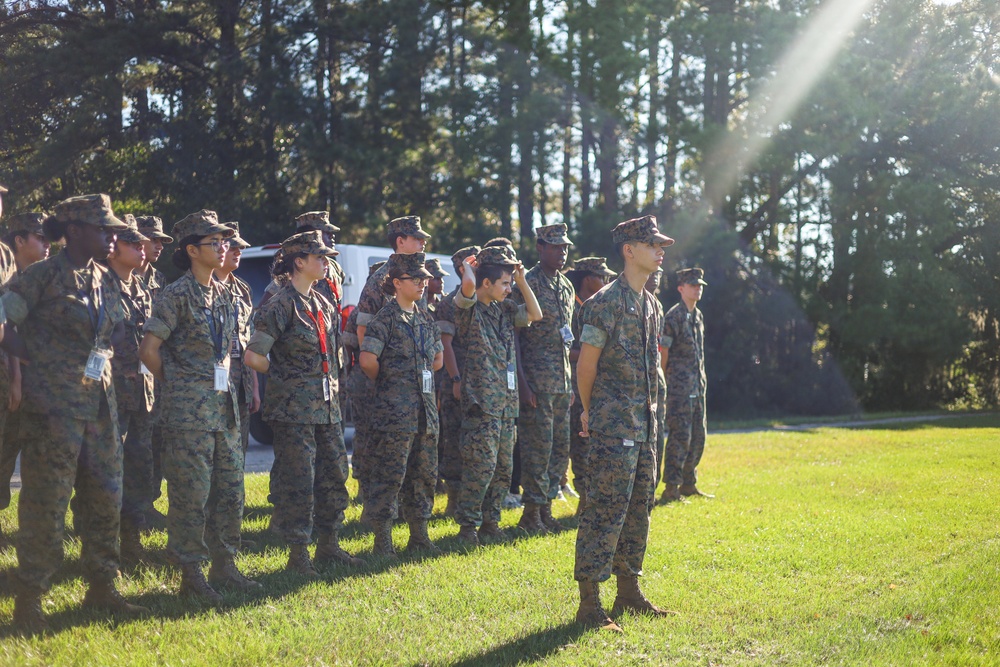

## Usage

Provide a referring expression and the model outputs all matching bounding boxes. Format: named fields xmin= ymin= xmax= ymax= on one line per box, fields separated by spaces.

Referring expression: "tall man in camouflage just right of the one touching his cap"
xmin=511 ymin=224 xmax=576 ymax=533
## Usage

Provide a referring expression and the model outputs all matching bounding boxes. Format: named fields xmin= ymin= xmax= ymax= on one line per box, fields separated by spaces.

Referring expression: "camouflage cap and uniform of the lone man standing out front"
xmin=574 ymin=216 xmax=666 ymax=583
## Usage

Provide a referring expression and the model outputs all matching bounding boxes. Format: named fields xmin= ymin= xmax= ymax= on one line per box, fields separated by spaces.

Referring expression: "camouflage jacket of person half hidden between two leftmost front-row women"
xmin=111 ymin=272 xmax=153 ymax=412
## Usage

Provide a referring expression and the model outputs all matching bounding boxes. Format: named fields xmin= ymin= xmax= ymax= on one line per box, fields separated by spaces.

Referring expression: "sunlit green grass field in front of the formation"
xmin=0 ymin=416 xmax=1000 ymax=666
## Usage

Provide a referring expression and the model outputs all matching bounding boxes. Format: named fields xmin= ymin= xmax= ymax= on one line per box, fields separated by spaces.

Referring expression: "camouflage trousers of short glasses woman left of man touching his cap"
xmin=361 ymin=418 xmax=438 ymax=524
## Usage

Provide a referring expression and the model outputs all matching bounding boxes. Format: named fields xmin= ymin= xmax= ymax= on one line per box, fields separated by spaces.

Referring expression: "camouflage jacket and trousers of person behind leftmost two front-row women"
xmin=111 ymin=250 xmax=154 ymax=528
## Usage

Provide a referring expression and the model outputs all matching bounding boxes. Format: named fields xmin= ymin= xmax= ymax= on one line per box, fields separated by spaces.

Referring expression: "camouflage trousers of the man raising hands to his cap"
xmin=455 ymin=405 xmax=517 ymax=526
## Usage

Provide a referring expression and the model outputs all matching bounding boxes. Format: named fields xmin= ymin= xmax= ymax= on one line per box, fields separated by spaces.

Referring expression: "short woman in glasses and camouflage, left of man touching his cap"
xmin=360 ymin=252 xmax=444 ymax=556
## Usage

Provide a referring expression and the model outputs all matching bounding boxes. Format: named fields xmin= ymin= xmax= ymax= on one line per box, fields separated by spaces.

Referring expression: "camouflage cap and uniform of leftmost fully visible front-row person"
xmin=3 ymin=195 xmax=131 ymax=595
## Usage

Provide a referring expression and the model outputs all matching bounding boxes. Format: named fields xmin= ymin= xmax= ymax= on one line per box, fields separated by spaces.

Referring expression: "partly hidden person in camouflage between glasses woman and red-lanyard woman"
xmin=215 ymin=222 xmax=260 ymax=456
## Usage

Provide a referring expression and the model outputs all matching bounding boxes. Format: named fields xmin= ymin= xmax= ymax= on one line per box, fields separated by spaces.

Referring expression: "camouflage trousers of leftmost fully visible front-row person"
xmin=17 ymin=399 xmax=122 ymax=593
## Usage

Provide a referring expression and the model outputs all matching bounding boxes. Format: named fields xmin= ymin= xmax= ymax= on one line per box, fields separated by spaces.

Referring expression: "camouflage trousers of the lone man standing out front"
xmin=574 ymin=431 xmax=655 ymax=583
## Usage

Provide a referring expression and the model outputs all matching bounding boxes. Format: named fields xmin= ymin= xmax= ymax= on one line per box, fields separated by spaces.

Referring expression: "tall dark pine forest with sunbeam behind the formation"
xmin=0 ymin=0 xmax=1000 ymax=417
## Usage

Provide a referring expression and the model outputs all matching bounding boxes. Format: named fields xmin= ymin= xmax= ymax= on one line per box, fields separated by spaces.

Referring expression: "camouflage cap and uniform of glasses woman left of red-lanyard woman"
xmin=144 ymin=211 xmax=244 ymax=565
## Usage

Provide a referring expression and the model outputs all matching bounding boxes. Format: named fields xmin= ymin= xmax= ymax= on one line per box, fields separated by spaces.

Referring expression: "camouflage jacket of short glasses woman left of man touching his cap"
xmin=361 ymin=300 xmax=444 ymax=433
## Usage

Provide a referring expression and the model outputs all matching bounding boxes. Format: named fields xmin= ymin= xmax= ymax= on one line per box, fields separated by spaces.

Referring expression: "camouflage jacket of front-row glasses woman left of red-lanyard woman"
xmin=143 ymin=271 xmax=239 ymax=432
